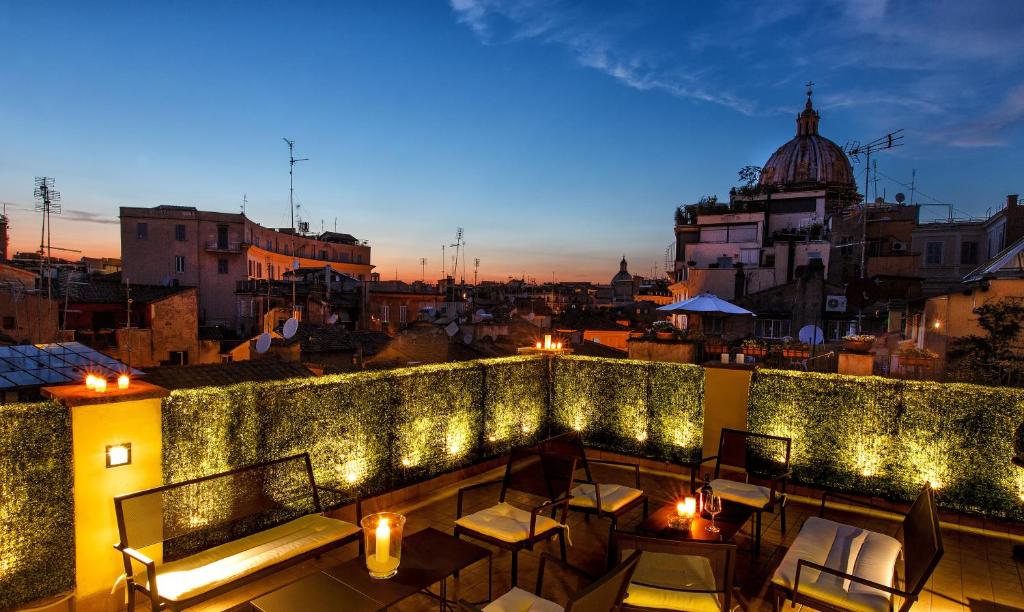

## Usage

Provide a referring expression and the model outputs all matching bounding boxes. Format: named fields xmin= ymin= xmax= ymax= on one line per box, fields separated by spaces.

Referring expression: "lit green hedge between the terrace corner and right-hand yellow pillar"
xmin=551 ymin=357 xmax=703 ymax=461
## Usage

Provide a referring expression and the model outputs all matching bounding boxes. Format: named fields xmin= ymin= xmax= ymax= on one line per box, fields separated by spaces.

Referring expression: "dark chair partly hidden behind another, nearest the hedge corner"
xmin=539 ymin=431 xmax=647 ymax=529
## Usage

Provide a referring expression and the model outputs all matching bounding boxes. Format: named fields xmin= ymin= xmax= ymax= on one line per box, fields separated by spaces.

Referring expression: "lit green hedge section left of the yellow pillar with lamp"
xmin=0 ymin=402 xmax=75 ymax=610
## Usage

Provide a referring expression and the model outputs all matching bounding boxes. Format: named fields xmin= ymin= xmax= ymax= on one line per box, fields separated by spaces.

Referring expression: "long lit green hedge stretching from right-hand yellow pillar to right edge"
xmin=748 ymin=369 xmax=1024 ymax=519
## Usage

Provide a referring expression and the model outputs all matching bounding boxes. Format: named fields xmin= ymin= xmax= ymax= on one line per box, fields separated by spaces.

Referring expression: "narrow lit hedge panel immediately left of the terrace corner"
xmin=477 ymin=355 xmax=550 ymax=457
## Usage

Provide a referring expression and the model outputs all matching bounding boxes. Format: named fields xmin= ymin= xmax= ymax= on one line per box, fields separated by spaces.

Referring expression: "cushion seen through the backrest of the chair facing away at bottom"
xmin=622 ymin=550 xmax=722 ymax=612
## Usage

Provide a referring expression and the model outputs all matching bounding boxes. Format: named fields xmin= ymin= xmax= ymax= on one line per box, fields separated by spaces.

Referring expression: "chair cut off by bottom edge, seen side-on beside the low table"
xmin=459 ymin=553 xmax=640 ymax=612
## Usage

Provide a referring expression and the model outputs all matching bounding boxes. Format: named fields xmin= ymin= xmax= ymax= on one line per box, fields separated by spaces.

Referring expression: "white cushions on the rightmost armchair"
xmin=771 ymin=517 xmax=901 ymax=612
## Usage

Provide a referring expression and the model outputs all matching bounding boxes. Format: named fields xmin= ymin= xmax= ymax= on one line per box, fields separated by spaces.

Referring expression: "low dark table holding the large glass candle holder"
xmin=251 ymin=527 xmax=492 ymax=612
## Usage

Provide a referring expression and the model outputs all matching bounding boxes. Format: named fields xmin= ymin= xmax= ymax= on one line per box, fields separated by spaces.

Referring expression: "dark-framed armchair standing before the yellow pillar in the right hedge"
xmin=700 ymin=428 xmax=793 ymax=555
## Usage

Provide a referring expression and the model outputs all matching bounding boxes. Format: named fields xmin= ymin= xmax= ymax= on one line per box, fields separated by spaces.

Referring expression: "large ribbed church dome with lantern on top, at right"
xmin=758 ymin=91 xmax=856 ymax=189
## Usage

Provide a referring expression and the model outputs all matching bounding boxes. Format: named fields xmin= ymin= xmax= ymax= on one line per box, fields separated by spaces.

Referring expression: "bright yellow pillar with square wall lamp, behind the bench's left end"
xmin=72 ymin=398 xmax=162 ymax=612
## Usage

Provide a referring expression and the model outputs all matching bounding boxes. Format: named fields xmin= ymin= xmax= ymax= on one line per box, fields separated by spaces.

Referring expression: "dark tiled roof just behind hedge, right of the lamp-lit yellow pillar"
xmin=145 ymin=359 xmax=312 ymax=390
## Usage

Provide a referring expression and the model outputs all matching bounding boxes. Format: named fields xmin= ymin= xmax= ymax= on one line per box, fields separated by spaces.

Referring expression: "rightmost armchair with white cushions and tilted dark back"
xmin=771 ymin=484 xmax=942 ymax=612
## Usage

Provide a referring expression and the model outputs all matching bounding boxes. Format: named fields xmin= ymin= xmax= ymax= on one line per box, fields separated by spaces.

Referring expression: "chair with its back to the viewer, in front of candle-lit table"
xmin=608 ymin=530 xmax=736 ymax=611
